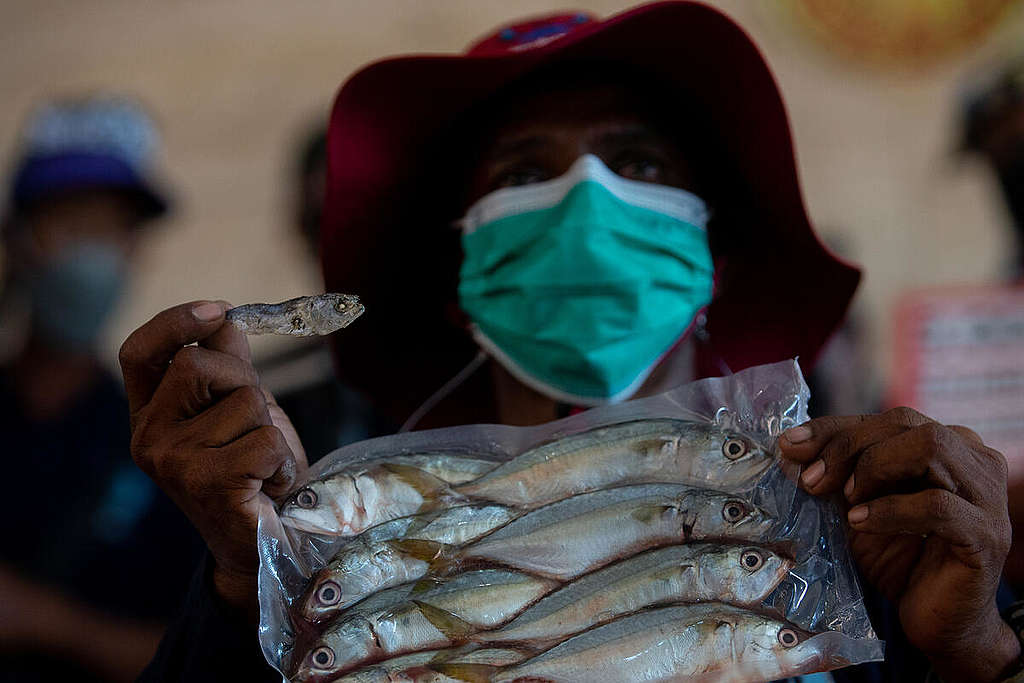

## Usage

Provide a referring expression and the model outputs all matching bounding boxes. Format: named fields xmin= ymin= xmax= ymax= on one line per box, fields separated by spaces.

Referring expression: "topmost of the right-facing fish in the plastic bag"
xmin=456 ymin=420 xmax=772 ymax=507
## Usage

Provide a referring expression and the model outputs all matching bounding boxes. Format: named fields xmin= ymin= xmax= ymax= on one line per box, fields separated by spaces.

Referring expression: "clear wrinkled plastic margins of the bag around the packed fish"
xmin=258 ymin=360 xmax=883 ymax=680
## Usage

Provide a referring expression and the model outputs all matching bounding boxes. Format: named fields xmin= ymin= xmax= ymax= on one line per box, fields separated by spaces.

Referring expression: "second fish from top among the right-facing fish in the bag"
xmin=432 ymin=484 xmax=773 ymax=581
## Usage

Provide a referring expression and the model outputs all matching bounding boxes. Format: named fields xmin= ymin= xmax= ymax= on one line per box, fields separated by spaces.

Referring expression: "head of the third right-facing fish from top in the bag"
xmin=697 ymin=546 xmax=794 ymax=604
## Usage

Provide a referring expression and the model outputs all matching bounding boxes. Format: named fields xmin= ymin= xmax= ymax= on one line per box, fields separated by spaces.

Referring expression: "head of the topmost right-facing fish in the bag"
xmin=676 ymin=424 xmax=774 ymax=489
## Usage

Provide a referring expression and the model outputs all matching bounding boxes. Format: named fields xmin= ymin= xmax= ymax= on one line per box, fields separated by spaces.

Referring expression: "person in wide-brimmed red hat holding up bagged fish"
xmin=121 ymin=2 xmax=1020 ymax=681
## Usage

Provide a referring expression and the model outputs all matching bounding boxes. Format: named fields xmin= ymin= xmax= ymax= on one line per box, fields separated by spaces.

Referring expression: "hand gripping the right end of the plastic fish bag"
xmin=779 ymin=408 xmax=1020 ymax=683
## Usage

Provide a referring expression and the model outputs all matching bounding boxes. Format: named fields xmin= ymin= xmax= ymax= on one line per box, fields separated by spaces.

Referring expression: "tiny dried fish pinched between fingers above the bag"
xmin=225 ymin=294 xmax=365 ymax=337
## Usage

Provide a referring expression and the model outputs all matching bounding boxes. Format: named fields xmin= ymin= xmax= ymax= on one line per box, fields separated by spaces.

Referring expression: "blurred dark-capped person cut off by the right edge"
xmin=962 ymin=54 xmax=1024 ymax=280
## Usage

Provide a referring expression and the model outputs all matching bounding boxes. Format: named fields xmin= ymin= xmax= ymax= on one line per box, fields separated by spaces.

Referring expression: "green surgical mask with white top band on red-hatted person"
xmin=459 ymin=155 xmax=714 ymax=405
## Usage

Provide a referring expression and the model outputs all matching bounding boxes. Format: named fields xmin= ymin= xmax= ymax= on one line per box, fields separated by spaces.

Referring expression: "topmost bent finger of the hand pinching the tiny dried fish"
xmin=118 ymin=301 xmax=224 ymax=413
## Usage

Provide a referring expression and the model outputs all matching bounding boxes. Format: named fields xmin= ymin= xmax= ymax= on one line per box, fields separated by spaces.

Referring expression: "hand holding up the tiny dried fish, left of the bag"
xmin=120 ymin=301 xmax=306 ymax=620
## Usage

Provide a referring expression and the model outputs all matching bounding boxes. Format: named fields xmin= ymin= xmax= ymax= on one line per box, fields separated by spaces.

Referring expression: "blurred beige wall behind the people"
xmin=0 ymin=0 xmax=1024 ymax=389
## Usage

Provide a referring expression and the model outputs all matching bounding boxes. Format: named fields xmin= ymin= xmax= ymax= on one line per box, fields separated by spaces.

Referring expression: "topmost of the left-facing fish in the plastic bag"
xmin=281 ymin=453 xmax=496 ymax=536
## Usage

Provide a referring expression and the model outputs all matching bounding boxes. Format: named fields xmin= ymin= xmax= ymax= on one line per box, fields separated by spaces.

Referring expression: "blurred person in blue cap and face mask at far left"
xmin=0 ymin=96 xmax=201 ymax=682
